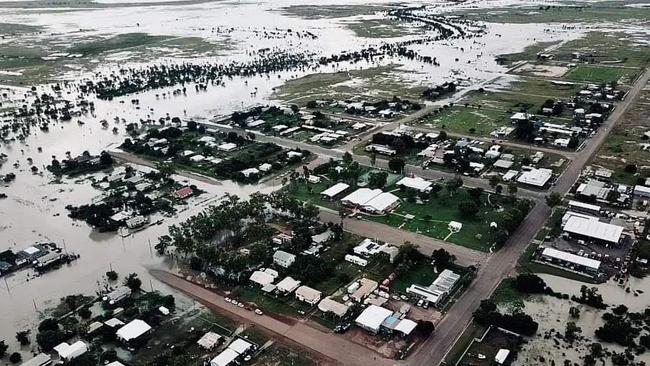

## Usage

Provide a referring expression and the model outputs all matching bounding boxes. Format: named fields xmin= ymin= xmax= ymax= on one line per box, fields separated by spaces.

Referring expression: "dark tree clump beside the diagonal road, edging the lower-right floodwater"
xmin=474 ymin=300 xmax=539 ymax=336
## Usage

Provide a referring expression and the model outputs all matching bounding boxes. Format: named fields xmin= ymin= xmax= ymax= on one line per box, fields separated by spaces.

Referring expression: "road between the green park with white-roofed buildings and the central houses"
xmin=319 ymin=209 xmax=488 ymax=266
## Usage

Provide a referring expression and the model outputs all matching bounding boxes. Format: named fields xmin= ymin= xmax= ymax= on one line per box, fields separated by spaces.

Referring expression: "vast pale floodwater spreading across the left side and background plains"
xmin=0 ymin=0 xmax=636 ymax=349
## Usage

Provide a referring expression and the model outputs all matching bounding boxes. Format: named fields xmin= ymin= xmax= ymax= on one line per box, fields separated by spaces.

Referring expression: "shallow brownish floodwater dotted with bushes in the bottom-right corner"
xmin=513 ymin=274 xmax=650 ymax=366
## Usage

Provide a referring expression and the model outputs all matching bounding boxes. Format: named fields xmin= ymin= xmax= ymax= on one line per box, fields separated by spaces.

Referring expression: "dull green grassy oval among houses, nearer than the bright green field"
xmin=424 ymin=106 xmax=510 ymax=137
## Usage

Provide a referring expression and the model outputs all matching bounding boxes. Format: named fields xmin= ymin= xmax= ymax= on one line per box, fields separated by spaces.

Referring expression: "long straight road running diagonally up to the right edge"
xmin=408 ymin=70 xmax=650 ymax=366
